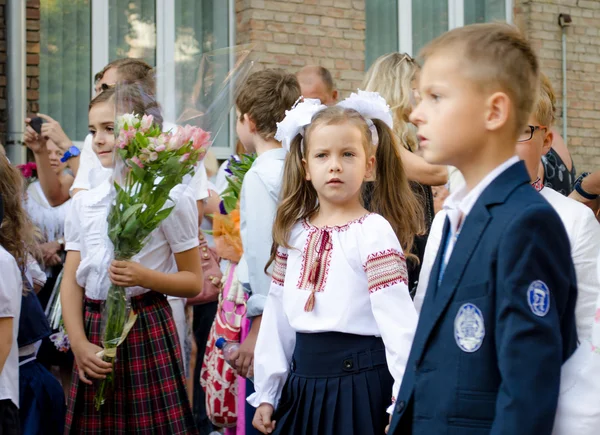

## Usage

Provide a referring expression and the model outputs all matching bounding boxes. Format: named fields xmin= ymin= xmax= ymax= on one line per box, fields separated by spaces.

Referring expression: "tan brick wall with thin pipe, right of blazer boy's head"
xmin=514 ymin=0 xmax=600 ymax=173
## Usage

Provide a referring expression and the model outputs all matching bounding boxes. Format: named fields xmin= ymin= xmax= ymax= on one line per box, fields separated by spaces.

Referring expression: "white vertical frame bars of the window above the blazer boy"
xmin=398 ymin=0 xmax=514 ymax=56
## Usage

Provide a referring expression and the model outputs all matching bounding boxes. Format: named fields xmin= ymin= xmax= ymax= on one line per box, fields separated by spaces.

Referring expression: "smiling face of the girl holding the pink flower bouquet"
xmin=89 ymin=101 xmax=115 ymax=168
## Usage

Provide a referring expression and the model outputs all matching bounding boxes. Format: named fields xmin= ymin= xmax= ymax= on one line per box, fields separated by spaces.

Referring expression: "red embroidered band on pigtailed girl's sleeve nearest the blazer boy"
xmin=363 ymin=249 xmax=408 ymax=293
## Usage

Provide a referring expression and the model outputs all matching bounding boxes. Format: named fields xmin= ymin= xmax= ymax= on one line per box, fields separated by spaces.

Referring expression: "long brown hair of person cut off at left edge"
xmin=0 ymin=155 xmax=38 ymax=272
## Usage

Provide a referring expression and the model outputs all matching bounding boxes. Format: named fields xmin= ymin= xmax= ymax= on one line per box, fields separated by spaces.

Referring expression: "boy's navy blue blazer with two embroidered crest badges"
xmin=388 ymin=162 xmax=577 ymax=435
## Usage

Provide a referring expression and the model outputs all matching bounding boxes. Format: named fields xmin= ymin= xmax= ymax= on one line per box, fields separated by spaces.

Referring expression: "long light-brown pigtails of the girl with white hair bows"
xmin=265 ymin=106 xmax=424 ymax=270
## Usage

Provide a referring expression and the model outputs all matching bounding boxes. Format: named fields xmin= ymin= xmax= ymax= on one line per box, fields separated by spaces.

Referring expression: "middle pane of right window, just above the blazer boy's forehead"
xmin=412 ymin=0 xmax=448 ymax=56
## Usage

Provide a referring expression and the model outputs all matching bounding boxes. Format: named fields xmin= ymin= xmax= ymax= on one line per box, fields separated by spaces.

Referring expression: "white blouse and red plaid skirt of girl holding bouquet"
xmin=65 ymin=180 xmax=198 ymax=434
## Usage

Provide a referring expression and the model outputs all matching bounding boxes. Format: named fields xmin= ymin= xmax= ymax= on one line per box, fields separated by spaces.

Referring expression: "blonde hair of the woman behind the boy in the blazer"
xmin=362 ymin=53 xmax=419 ymax=151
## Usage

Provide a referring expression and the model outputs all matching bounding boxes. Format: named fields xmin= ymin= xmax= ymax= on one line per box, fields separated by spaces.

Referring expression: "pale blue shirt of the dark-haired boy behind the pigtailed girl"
xmin=237 ymin=148 xmax=287 ymax=317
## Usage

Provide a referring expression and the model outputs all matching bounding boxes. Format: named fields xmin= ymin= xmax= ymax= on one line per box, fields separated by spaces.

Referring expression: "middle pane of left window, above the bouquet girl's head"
xmin=108 ymin=0 xmax=156 ymax=66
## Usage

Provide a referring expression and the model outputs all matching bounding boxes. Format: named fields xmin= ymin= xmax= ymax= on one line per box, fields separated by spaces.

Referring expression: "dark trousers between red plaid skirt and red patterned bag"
xmin=193 ymin=302 xmax=218 ymax=435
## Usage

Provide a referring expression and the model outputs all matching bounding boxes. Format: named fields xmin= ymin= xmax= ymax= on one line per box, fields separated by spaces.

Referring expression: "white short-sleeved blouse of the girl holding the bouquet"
xmin=65 ymin=180 xmax=198 ymax=300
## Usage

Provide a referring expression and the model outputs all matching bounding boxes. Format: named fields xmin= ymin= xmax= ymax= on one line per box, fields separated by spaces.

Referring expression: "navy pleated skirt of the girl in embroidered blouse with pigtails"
xmin=273 ymin=332 xmax=394 ymax=435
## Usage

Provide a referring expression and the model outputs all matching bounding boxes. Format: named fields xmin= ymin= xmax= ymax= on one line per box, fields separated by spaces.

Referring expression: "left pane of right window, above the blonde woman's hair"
xmin=365 ymin=0 xmax=398 ymax=69
